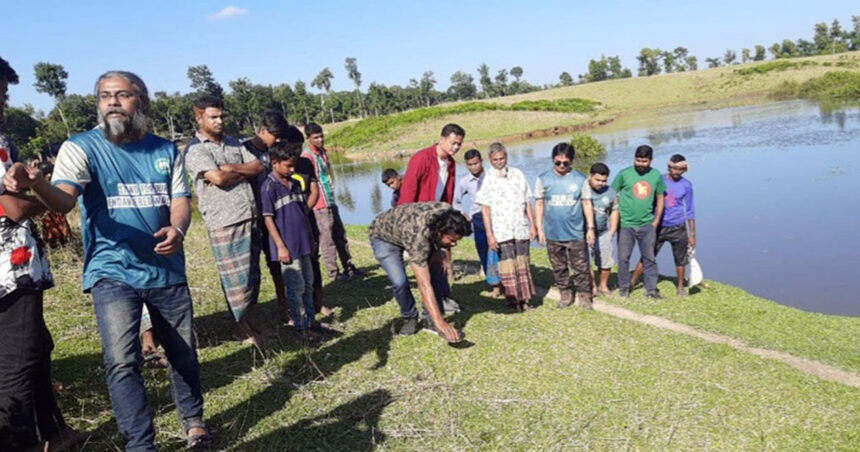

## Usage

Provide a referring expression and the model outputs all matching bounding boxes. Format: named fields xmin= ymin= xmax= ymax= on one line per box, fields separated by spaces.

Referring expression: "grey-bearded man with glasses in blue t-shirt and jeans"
xmin=5 ymin=71 xmax=212 ymax=451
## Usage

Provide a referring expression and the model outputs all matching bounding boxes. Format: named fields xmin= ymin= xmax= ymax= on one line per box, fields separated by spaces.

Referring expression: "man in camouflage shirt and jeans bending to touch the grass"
xmin=367 ymin=202 xmax=472 ymax=342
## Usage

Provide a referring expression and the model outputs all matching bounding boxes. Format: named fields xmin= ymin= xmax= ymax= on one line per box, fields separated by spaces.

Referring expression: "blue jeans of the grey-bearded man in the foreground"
xmin=92 ymin=279 xmax=203 ymax=452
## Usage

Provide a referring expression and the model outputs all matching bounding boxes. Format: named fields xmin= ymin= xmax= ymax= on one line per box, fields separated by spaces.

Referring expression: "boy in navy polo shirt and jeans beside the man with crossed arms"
xmin=260 ymin=142 xmax=320 ymax=341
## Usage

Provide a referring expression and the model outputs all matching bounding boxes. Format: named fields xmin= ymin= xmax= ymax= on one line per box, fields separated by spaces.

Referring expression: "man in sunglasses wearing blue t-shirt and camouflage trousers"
xmin=535 ymin=143 xmax=594 ymax=309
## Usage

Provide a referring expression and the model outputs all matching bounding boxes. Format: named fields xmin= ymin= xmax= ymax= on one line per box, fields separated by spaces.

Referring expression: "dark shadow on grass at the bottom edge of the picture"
xmin=235 ymin=389 xmax=394 ymax=451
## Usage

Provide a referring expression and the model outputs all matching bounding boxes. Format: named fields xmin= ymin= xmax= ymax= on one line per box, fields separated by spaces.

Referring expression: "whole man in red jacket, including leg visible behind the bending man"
xmin=397 ymin=124 xmax=466 ymax=314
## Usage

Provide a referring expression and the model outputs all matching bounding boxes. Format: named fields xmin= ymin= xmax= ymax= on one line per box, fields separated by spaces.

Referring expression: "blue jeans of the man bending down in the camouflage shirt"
xmin=370 ymin=239 xmax=451 ymax=319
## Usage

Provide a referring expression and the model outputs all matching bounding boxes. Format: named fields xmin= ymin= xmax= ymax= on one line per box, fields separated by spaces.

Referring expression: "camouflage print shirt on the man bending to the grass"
xmin=367 ymin=202 xmax=451 ymax=267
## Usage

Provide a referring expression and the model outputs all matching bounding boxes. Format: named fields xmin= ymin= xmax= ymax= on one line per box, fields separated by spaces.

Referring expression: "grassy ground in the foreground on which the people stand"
xmin=46 ymin=220 xmax=860 ymax=451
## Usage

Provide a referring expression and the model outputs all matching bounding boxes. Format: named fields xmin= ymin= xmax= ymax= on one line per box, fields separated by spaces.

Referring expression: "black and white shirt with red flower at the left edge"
xmin=0 ymin=133 xmax=54 ymax=298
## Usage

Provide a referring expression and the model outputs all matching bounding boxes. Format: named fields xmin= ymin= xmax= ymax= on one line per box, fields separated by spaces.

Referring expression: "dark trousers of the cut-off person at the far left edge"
xmin=0 ymin=290 xmax=66 ymax=451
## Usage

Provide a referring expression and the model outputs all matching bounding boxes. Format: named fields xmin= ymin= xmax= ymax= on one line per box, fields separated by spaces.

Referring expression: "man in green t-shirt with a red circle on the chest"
xmin=612 ymin=145 xmax=666 ymax=299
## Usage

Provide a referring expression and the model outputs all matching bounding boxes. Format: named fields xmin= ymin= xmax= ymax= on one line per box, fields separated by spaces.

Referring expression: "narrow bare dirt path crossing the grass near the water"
xmin=350 ymin=240 xmax=860 ymax=388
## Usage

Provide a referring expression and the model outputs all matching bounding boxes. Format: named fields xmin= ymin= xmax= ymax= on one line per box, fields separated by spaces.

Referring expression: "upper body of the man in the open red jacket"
xmin=398 ymin=124 xmax=466 ymax=206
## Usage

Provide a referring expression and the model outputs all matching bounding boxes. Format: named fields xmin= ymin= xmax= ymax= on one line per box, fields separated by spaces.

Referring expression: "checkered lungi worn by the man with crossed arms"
xmin=209 ymin=220 xmax=260 ymax=322
